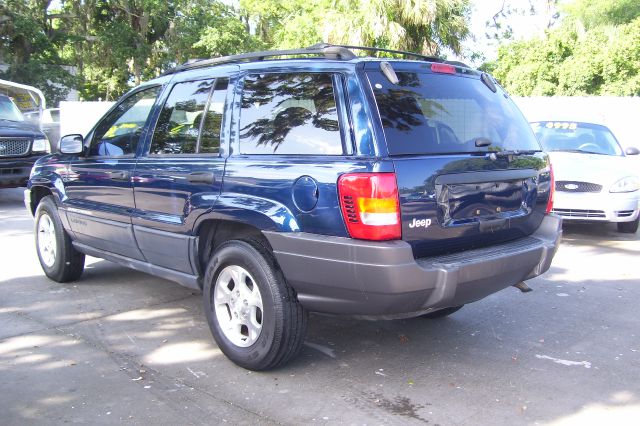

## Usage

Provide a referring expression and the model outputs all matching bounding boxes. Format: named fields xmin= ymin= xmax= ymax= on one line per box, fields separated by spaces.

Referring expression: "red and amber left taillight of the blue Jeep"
xmin=338 ymin=173 xmax=402 ymax=241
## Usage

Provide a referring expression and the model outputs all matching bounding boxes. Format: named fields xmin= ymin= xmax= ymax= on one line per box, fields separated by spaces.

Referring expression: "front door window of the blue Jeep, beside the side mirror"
xmin=89 ymin=86 xmax=160 ymax=157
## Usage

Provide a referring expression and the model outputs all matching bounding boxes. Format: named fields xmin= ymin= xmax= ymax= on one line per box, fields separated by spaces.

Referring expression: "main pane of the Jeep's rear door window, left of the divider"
xmin=149 ymin=80 xmax=213 ymax=154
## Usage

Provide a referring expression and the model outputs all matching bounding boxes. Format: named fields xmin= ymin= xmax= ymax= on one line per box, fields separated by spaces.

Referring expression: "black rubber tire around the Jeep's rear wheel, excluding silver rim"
xmin=203 ymin=240 xmax=307 ymax=371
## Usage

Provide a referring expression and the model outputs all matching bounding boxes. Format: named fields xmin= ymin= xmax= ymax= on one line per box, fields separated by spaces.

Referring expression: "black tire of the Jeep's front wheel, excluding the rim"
xmin=35 ymin=195 xmax=84 ymax=283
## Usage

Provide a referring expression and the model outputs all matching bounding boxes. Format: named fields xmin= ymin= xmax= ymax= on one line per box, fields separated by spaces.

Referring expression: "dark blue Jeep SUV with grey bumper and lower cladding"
xmin=25 ymin=45 xmax=561 ymax=370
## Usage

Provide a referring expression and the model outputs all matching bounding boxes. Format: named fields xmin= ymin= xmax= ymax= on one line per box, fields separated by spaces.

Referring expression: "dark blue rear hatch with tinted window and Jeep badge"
xmin=365 ymin=61 xmax=551 ymax=257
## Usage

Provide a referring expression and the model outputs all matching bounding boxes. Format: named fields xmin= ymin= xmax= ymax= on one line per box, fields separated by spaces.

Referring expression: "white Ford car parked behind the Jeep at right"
xmin=531 ymin=121 xmax=640 ymax=233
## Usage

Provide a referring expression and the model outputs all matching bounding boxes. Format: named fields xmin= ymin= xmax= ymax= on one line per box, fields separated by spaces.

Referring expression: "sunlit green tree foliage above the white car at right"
xmin=488 ymin=0 xmax=640 ymax=96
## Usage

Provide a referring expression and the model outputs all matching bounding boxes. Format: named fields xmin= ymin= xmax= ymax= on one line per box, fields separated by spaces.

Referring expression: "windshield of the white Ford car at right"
xmin=531 ymin=121 xmax=622 ymax=155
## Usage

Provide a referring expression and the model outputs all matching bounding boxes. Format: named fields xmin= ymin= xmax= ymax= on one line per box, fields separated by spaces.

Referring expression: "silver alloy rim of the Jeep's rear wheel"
xmin=213 ymin=265 xmax=263 ymax=348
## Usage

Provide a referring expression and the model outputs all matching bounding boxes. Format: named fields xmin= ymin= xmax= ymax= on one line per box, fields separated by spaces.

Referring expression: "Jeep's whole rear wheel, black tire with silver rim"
xmin=203 ymin=240 xmax=307 ymax=371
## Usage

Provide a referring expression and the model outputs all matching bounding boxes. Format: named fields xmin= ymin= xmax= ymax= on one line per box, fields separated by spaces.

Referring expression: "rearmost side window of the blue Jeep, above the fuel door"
xmin=240 ymin=73 xmax=343 ymax=155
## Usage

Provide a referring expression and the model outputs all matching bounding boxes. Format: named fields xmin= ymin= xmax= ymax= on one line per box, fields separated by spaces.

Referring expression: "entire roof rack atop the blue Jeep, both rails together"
xmin=162 ymin=43 xmax=443 ymax=75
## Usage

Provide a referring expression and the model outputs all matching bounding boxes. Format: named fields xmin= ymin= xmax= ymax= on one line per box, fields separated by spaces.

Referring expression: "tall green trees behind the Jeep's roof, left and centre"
xmin=0 ymin=0 xmax=470 ymax=104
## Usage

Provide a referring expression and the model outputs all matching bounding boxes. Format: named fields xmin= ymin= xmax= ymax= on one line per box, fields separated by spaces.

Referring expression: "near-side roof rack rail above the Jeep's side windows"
xmin=162 ymin=43 xmax=356 ymax=75
